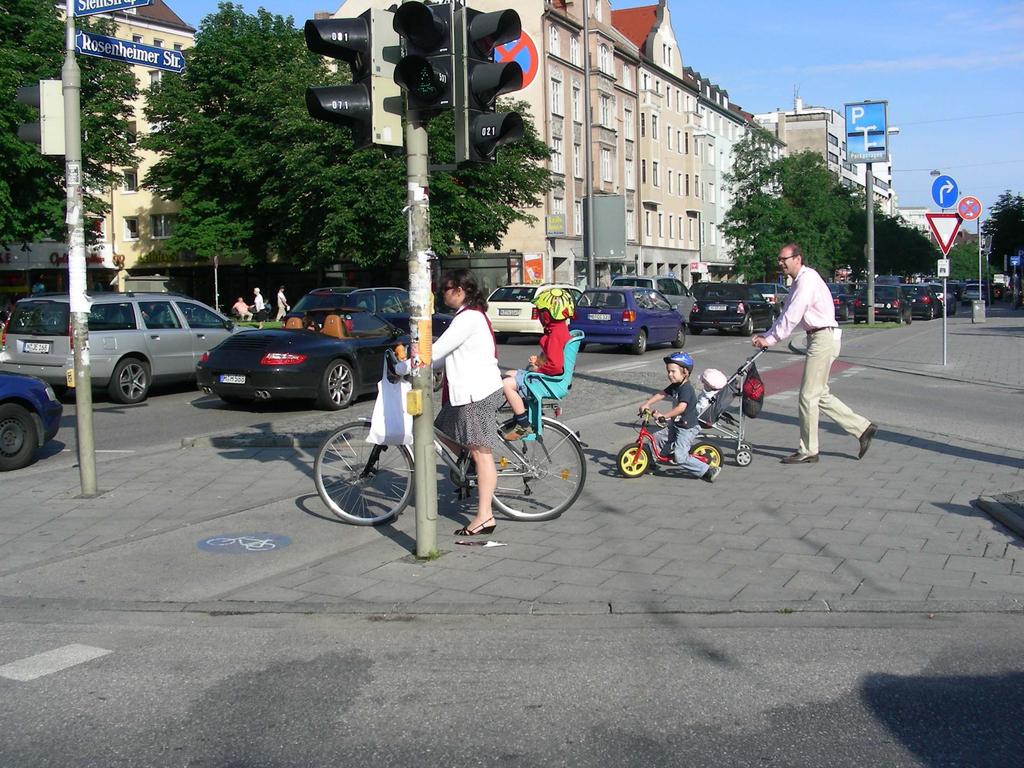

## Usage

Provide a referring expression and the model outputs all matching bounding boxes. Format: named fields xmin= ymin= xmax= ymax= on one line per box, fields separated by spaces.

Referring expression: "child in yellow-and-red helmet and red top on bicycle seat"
xmin=502 ymin=288 xmax=574 ymax=440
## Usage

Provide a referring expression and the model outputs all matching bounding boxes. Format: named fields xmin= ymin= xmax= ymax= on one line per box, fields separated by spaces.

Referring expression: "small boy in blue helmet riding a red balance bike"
xmin=640 ymin=352 xmax=720 ymax=482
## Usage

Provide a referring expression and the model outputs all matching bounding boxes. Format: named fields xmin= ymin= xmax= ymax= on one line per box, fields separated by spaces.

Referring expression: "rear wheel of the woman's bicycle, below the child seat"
xmin=495 ymin=417 xmax=587 ymax=520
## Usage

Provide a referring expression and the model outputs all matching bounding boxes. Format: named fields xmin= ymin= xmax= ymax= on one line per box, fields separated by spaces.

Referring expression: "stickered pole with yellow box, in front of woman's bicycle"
xmin=406 ymin=115 xmax=437 ymax=558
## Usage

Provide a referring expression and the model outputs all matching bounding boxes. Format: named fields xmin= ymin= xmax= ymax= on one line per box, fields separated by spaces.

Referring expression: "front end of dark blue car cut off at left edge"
xmin=0 ymin=374 xmax=63 ymax=472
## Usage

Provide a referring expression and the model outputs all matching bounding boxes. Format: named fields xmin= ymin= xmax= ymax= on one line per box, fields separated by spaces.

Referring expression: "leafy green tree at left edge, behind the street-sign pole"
xmin=0 ymin=0 xmax=137 ymax=243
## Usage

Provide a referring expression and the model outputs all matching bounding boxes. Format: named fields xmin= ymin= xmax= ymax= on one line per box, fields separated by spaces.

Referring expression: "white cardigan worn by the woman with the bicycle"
xmin=431 ymin=307 xmax=502 ymax=406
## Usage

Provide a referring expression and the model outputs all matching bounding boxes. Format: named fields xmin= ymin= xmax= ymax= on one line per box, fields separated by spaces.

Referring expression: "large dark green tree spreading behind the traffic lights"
xmin=143 ymin=3 xmax=551 ymax=266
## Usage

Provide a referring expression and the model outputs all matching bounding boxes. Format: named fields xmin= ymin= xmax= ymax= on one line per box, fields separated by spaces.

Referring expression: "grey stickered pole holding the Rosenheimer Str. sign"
xmin=60 ymin=10 xmax=96 ymax=496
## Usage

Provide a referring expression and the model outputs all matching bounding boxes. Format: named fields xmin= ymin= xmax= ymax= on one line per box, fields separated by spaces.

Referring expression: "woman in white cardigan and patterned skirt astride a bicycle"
xmin=432 ymin=269 xmax=505 ymax=536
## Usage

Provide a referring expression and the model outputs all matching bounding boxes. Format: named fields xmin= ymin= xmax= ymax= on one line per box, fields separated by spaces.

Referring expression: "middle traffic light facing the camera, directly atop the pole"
xmin=394 ymin=2 xmax=455 ymax=113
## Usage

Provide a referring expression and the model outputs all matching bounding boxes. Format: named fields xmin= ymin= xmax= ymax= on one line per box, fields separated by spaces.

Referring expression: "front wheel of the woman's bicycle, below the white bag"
xmin=313 ymin=420 xmax=413 ymax=525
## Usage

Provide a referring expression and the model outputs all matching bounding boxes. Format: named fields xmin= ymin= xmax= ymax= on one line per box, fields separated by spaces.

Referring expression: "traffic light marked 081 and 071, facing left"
xmin=303 ymin=8 xmax=402 ymax=150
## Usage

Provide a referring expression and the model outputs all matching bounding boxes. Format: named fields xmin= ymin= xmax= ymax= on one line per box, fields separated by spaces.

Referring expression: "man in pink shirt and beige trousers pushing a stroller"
xmin=753 ymin=243 xmax=878 ymax=464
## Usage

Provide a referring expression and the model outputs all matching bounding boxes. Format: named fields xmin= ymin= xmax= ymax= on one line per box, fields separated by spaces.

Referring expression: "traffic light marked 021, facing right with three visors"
xmin=455 ymin=8 xmax=523 ymax=163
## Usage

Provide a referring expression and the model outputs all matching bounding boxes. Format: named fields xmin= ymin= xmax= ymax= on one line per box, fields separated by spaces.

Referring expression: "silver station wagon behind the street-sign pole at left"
xmin=0 ymin=293 xmax=237 ymax=403
